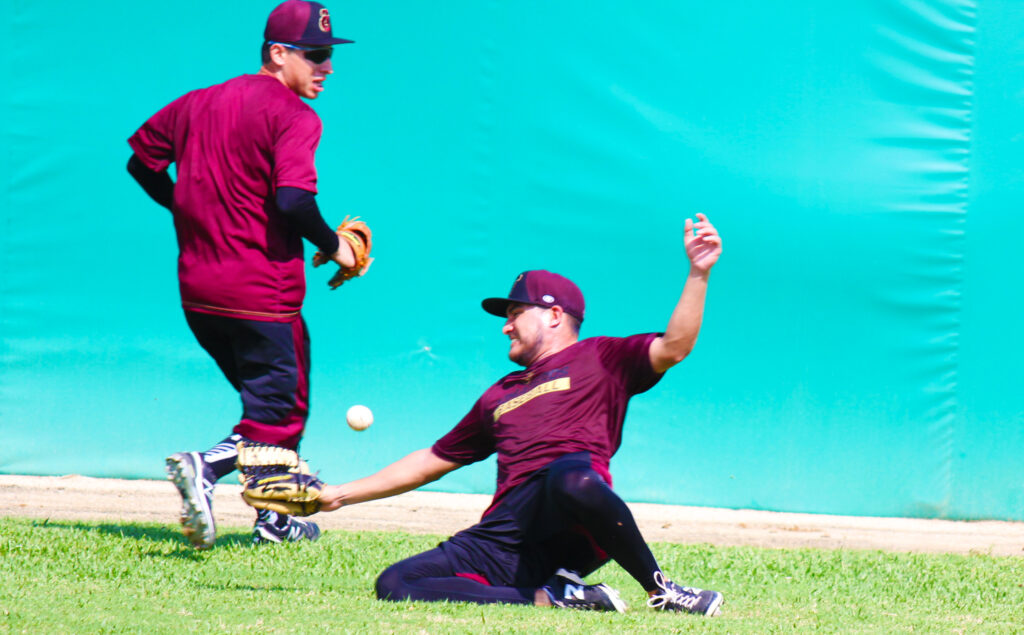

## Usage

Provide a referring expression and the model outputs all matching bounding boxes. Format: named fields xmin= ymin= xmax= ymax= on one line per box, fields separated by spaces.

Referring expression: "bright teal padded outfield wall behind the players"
xmin=0 ymin=0 xmax=1024 ymax=519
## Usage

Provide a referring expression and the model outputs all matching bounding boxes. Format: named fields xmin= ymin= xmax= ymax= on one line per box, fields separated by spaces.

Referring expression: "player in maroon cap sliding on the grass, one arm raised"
xmin=264 ymin=214 xmax=723 ymax=616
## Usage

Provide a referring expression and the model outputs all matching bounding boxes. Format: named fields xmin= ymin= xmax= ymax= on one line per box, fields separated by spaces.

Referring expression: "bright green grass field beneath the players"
xmin=0 ymin=517 xmax=1024 ymax=634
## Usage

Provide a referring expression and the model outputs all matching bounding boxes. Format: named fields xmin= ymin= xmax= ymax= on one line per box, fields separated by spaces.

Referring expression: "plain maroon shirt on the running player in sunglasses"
xmin=128 ymin=75 xmax=322 ymax=322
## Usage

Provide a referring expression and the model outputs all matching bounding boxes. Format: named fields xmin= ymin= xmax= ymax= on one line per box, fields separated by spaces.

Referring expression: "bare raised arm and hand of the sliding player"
xmin=648 ymin=214 xmax=722 ymax=373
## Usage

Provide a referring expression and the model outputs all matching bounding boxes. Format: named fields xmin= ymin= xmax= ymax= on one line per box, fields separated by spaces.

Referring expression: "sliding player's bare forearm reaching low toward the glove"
xmin=319 ymin=448 xmax=462 ymax=511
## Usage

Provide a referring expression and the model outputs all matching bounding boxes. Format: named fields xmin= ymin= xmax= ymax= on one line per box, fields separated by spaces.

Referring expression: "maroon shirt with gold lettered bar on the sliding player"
xmin=432 ymin=333 xmax=662 ymax=509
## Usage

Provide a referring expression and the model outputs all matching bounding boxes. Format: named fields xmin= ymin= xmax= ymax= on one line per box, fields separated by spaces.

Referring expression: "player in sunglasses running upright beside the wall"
xmin=128 ymin=0 xmax=371 ymax=549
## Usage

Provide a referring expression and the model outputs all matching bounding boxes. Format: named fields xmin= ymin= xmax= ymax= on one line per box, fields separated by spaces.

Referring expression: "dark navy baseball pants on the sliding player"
xmin=377 ymin=453 xmax=657 ymax=604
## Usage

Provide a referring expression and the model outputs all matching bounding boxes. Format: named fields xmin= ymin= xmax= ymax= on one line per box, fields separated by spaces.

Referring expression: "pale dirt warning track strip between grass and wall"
xmin=0 ymin=474 xmax=1024 ymax=556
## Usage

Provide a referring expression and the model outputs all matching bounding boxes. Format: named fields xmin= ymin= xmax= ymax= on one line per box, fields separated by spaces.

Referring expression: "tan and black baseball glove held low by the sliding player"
xmin=236 ymin=440 xmax=324 ymax=516
